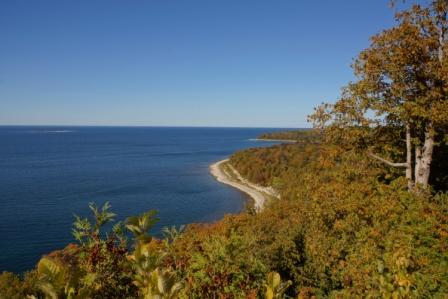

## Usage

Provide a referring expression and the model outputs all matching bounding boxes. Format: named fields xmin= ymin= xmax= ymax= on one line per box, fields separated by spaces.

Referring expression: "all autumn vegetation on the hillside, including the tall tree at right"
xmin=0 ymin=0 xmax=448 ymax=299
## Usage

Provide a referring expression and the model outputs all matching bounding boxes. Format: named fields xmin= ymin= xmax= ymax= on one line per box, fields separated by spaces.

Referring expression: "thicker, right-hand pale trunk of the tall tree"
xmin=415 ymin=123 xmax=434 ymax=188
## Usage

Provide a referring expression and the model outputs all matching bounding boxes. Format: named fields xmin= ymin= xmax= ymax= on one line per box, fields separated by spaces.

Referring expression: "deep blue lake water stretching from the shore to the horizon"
xmin=0 ymin=126 xmax=286 ymax=272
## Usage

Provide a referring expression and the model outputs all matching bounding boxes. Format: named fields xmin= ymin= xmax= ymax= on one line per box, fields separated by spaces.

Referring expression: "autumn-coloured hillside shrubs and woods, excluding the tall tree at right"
xmin=0 ymin=132 xmax=448 ymax=298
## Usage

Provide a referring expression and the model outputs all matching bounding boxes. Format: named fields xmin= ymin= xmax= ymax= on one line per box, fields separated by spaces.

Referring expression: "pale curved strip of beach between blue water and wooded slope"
xmin=209 ymin=159 xmax=280 ymax=212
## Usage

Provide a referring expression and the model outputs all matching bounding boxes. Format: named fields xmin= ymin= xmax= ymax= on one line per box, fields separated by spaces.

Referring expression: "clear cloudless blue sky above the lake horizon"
xmin=0 ymin=0 xmax=412 ymax=127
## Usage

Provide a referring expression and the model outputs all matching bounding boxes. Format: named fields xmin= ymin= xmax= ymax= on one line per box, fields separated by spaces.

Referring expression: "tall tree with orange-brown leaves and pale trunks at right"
xmin=310 ymin=0 xmax=448 ymax=188
